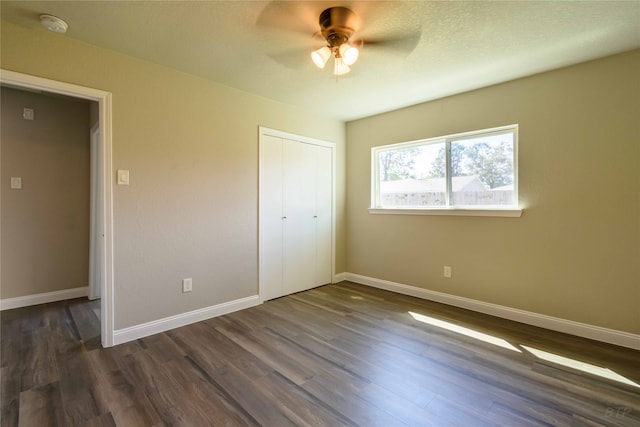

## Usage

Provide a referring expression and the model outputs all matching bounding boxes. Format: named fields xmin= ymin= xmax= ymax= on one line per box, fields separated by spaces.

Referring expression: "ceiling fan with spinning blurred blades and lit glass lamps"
xmin=256 ymin=1 xmax=422 ymax=76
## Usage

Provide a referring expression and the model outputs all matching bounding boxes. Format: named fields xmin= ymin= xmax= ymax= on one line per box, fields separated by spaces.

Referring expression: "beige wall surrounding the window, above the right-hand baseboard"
xmin=347 ymin=51 xmax=640 ymax=334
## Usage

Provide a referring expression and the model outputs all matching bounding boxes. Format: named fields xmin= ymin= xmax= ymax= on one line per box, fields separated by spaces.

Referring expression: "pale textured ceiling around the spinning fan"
xmin=0 ymin=0 xmax=640 ymax=121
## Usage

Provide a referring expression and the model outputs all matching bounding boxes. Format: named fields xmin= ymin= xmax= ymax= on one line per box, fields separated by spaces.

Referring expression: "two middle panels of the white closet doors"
xmin=283 ymin=140 xmax=317 ymax=294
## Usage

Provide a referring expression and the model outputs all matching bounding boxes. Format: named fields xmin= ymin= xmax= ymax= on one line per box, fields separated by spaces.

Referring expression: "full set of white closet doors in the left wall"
xmin=259 ymin=129 xmax=334 ymax=300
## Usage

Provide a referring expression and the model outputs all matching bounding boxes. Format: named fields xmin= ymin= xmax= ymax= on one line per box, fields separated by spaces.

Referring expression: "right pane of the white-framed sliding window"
xmin=451 ymin=132 xmax=515 ymax=206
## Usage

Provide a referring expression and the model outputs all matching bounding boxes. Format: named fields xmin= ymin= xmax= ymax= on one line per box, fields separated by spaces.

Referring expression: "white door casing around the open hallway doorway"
xmin=0 ymin=69 xmax=114 ymax=347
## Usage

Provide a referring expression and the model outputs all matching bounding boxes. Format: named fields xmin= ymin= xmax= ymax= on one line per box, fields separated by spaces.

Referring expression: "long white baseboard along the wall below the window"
xmin=336 ymin=273 xmax=640 ymax=350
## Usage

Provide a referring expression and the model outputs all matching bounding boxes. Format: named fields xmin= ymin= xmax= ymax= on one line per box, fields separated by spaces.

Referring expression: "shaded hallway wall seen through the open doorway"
xmin=0 ymin=88 xmax=89 ymax=299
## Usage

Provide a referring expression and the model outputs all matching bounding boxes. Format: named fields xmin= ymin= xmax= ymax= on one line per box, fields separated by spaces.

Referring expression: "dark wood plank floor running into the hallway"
xmin=1 ymin=282 xmax=640 ymax=427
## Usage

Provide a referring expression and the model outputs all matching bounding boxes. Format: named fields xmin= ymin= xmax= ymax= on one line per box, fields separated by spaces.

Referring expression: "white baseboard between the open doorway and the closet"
xmin=113 ymin=295 xmax=260 ymax=345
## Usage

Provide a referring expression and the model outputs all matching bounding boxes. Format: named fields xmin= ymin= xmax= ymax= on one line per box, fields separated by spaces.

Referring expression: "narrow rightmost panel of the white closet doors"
xmin=314 ymin=146 xmax=333 ymax=286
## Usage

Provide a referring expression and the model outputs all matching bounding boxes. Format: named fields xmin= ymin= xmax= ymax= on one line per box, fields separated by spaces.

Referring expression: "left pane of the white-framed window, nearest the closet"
xmin=378 ymin=142 xmax=446 ymax=207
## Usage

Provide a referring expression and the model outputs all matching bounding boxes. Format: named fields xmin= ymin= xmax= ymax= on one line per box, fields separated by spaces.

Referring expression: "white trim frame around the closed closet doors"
xmin=258 ymin=126 xmax=336 ymax=303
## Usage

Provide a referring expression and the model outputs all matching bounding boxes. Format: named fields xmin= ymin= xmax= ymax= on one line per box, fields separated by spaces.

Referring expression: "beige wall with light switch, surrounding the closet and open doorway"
xmin=1 ymin=21 xmax=345 ymax=329
